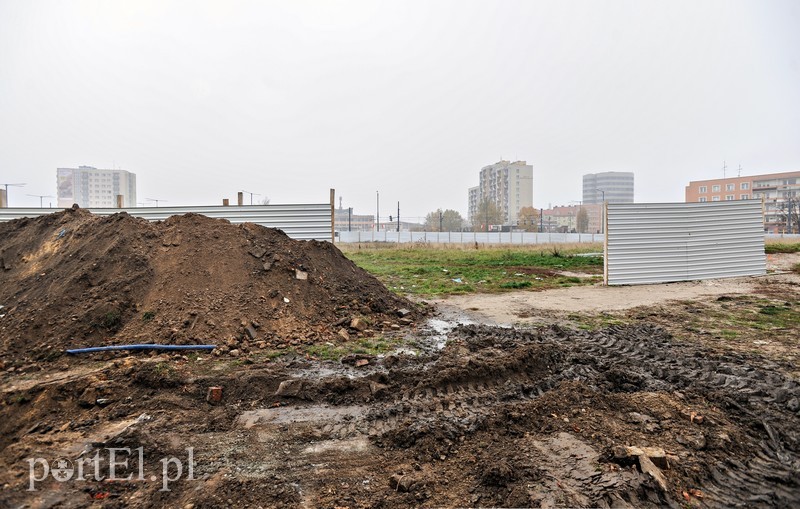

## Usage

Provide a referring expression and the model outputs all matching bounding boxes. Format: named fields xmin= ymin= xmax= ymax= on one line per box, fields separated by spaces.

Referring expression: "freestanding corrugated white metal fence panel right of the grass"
xmin=605 ymin=200 xmax=766 ymax=285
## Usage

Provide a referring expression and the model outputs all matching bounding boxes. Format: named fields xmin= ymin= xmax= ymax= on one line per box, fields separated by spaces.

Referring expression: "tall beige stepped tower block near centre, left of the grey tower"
xmin=468 ymin=161 xmax=533 ymax=226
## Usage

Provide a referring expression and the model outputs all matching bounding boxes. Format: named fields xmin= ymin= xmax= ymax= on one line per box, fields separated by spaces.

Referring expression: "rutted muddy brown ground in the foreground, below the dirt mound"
xmin=0 ymin=220 xmax=800 ymax=508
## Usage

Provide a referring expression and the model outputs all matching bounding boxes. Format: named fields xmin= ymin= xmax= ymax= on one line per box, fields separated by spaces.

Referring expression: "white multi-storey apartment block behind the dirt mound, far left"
xmin=57 ymin=166 xmax=136 ymax=208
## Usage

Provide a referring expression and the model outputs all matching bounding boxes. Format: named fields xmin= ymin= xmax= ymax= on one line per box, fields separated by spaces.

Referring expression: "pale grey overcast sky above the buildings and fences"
xmin=0 ymin=0 xmax=800 ymax=218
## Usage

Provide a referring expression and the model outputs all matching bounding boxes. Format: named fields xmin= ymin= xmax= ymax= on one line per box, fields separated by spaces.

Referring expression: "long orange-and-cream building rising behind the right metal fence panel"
xmin=686 ymin=171 xmax=800 ymax=233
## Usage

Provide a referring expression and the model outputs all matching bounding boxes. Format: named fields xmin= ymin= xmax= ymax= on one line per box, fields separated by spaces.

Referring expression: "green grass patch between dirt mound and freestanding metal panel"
xmin=345 ymin=246 xmax=603 ymax=296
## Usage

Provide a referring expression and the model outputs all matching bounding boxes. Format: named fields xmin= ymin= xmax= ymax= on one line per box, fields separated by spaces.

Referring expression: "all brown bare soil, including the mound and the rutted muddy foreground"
xmin=0 ymin=211 xmax=800 ymax=508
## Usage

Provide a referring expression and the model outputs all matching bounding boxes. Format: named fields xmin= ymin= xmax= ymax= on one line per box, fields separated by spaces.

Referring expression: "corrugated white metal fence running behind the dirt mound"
xmin=0 ymin=203 xmax=331 ymax=241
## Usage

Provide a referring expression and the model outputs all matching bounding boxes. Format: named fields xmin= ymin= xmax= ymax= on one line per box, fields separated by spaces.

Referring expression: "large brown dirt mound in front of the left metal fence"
xmin=0 ymin=209 xmax=422 ymax=361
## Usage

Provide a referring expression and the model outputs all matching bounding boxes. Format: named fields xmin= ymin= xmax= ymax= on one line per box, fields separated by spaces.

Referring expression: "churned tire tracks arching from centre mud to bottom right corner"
xmin=260 ymin=325 xmax=800 ymax=506
